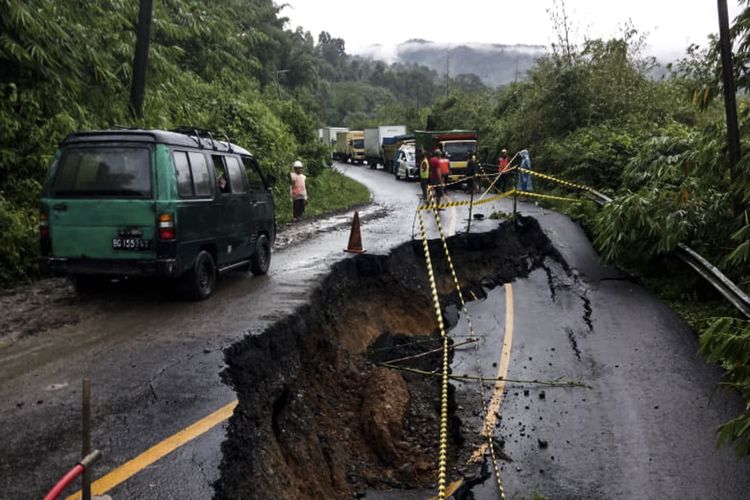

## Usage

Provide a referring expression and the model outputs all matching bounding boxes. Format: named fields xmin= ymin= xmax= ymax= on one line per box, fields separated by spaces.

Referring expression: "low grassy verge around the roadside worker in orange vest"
xmin=274 ymin=168 xmax=370 ymax=224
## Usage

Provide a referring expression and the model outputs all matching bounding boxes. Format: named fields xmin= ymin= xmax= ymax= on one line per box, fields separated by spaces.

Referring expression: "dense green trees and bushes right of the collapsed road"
xmin=464 ymin=2 xmax=750 ymax=456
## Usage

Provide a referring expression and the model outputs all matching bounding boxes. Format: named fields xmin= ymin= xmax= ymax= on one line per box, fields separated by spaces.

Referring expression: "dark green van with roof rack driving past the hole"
xmin=40 ymin=128 xmax=276 ymax=300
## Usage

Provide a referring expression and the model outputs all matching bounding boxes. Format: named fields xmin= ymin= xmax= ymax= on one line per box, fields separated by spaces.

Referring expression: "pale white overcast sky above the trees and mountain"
xmin=277 ymin=0 xmax=741 ymax=61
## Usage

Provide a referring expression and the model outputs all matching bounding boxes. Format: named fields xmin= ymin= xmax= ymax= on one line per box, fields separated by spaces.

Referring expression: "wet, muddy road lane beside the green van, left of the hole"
xmin=0 ymin=162 xmax=428 ymax=499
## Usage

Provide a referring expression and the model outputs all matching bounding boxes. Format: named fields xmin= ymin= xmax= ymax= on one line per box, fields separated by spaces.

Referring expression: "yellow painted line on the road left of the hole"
xmin=67 ymin=400 xmax=237 ymax=500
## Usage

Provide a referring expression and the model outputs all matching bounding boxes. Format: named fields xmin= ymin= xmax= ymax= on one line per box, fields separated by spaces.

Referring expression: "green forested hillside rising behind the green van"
xmin=0 ymin=0 xmax=456 ymax=286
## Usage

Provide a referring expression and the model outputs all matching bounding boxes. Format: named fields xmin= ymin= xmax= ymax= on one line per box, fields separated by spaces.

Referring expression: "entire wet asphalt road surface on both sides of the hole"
xmin=0 ymin=165 xmax=750 ymax=499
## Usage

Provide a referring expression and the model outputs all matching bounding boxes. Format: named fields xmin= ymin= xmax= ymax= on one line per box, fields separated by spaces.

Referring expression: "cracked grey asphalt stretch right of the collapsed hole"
xmin=453 ymin=206 xmax=750 ymax=500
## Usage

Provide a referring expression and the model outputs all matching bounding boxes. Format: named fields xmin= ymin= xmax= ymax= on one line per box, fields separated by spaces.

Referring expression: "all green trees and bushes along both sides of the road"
xmin=0 ymin=0 xmax=750 ymax=454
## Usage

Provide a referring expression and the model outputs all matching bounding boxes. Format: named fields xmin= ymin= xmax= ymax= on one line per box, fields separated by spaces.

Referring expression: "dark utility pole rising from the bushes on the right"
xmin=718 ymin=0 xmax=740 ymax=176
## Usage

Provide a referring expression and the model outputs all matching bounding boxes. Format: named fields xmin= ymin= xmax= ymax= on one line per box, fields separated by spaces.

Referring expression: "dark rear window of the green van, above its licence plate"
xmin=52 ymin=147 xmax=151 ymax=198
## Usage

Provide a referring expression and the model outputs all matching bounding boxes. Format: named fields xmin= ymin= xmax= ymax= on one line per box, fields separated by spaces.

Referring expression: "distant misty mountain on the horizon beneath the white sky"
xmin=358 ymin=39 xmax=546 ymax=87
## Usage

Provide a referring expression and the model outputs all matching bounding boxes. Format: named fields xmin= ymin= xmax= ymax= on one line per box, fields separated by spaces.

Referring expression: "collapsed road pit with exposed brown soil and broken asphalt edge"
xmin=215 ymin=218 xmax=560 ymax=499
